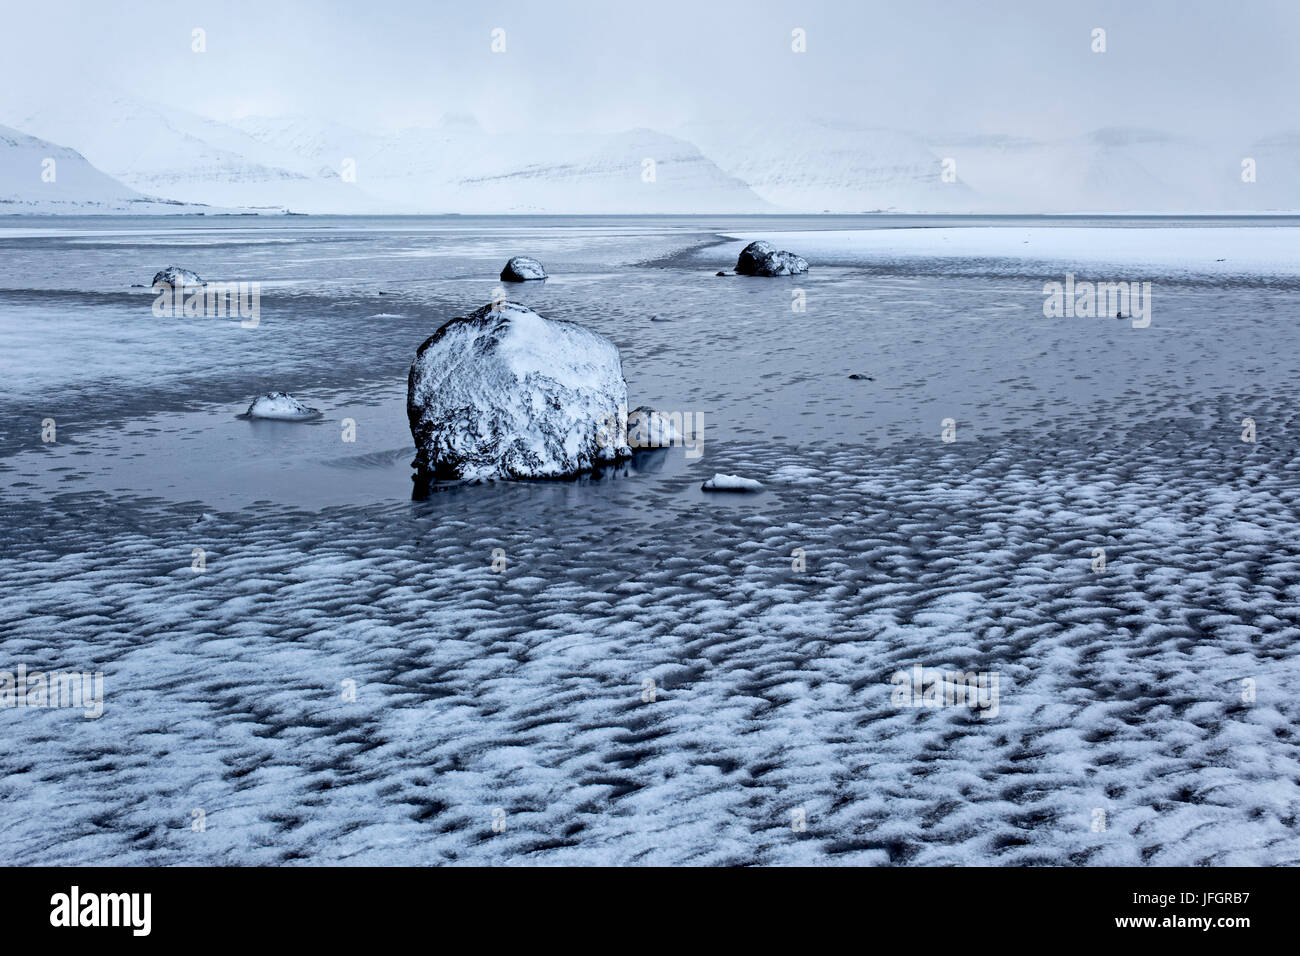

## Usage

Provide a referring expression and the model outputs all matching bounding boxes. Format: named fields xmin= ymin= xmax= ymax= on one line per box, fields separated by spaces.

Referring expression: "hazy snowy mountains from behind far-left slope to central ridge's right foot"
xmin=9 ymin=91 xmax=772 ymax=213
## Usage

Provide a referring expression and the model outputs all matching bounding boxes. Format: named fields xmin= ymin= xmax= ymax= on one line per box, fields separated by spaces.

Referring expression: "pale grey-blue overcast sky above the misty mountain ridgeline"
xmin=0 ymin=0 xmax=1300 ymax=139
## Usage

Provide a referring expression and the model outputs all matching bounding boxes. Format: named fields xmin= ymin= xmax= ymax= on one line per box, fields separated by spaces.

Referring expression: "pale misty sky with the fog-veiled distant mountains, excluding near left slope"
xmin=0 ymin=0 xmax=1300 ymax=213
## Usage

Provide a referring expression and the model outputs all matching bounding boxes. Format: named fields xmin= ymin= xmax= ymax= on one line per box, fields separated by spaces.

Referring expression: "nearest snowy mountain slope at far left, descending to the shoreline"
xmin=0 ymin=126 xmax=220 ymax=215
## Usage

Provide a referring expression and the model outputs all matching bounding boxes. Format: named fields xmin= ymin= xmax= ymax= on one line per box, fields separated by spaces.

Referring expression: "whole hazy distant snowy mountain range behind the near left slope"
xmin=0 ymin=90 xmax=1300 ymax=213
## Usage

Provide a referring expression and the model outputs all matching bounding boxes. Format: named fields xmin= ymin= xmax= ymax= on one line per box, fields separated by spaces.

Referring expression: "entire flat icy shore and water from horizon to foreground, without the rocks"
xmin=0 ymin=216 xmax=1300 ymax=865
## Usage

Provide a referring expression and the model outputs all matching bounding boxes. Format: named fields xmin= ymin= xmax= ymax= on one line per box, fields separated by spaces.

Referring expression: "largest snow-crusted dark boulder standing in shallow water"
xmin=407 ymin=302 xmax=632 ymax=480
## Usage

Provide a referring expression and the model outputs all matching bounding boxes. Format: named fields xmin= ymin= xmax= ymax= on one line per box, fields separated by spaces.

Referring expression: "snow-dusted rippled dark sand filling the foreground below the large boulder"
xmin=0 ymin=395 xmax=1300 ymax=865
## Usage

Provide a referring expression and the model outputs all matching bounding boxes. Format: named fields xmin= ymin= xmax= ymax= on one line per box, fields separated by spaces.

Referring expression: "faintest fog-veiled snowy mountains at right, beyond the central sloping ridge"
xmin=681 ymin=117 xmax=1300 ymax=213
